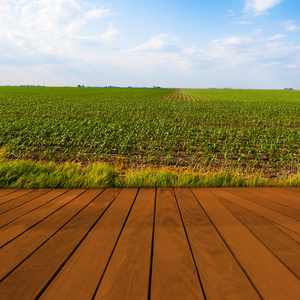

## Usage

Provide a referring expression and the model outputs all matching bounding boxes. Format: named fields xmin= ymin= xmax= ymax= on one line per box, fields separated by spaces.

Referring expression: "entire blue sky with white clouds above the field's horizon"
xmin=0 ymin=0 xmax=300 ymax=89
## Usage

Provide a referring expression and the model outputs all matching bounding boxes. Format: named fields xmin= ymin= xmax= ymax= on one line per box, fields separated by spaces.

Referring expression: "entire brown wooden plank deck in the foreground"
xmin=0 ymin=188 xmax=300 ymax=300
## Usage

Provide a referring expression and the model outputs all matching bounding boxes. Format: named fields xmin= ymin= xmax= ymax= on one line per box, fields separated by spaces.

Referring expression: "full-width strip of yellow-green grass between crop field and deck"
xmin=0 ymin=158 xmax=300 ymax=188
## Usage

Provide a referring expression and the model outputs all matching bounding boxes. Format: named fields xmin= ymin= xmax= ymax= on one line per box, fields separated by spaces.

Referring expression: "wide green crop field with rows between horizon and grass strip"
xmin=0 ymin=87 xmax=300 ymax=177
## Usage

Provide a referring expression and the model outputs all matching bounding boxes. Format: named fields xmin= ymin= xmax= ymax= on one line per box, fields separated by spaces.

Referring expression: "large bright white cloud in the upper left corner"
xmin=0 ymin=0 xmax=118 ymax=55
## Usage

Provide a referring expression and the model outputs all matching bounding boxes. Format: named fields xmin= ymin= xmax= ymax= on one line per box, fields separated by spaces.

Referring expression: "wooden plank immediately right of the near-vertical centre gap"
xmin=151 ymin=189 xmax=204 ymax=300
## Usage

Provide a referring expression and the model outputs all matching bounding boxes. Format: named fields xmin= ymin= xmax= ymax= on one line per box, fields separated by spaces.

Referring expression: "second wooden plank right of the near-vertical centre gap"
xmin=175 ymin=188 xmax=260 ymax=300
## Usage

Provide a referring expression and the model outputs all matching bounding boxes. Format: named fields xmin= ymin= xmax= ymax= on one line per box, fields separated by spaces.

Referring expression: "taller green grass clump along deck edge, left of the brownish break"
xmin=0 ymin=160 xmax=118 ymax=188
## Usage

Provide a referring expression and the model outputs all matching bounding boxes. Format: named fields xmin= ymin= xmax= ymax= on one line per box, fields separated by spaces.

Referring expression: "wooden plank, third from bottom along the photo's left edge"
xmin=0 ymin=189 xmax=85 ymax=247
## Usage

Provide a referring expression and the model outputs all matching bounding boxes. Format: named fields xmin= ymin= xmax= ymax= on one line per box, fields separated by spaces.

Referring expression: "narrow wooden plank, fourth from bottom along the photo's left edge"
xmin=0 ymin=189 xmax=68 ymax=227
